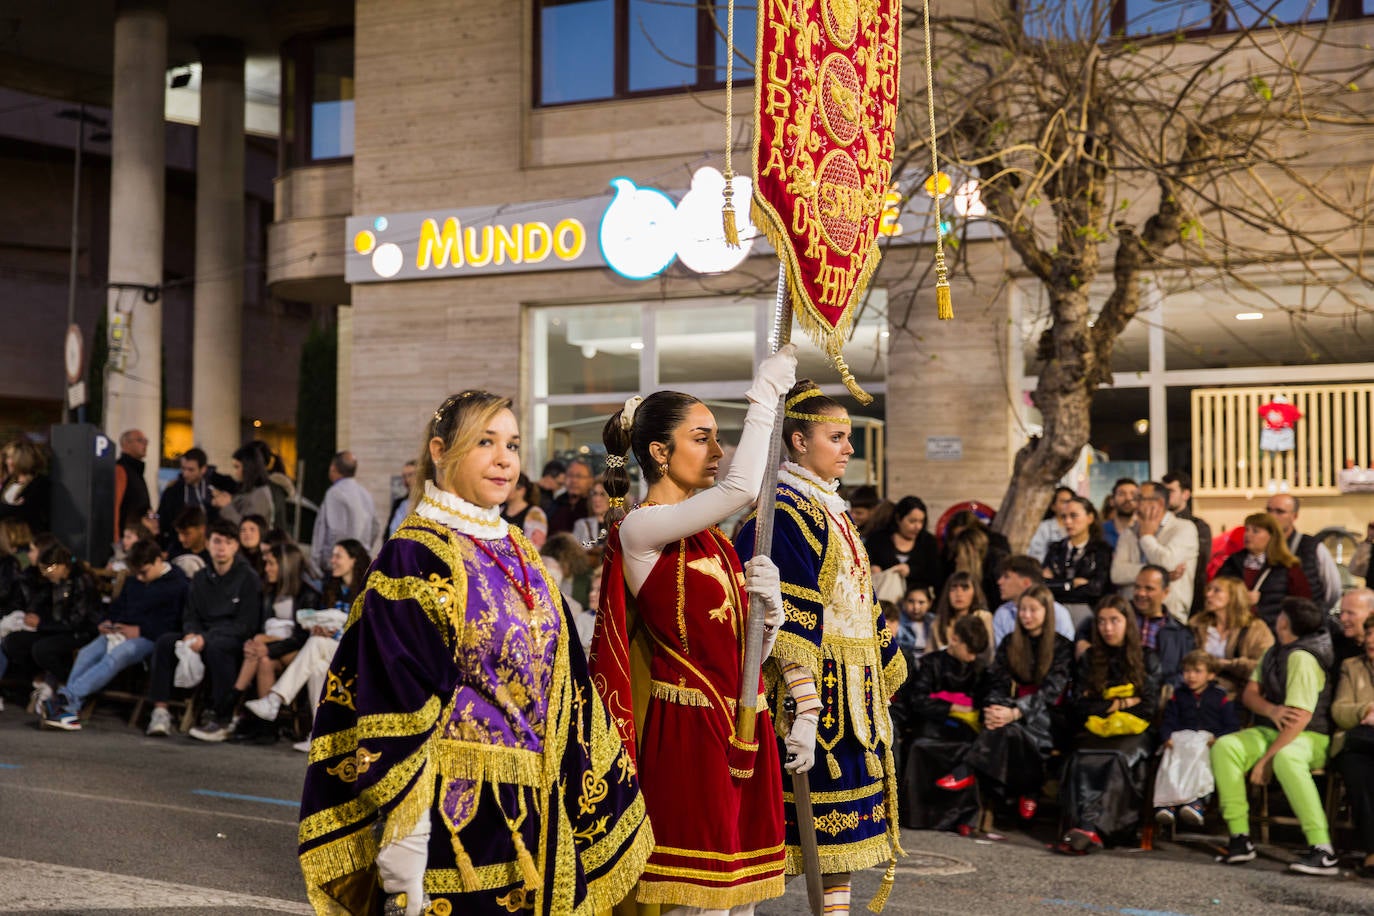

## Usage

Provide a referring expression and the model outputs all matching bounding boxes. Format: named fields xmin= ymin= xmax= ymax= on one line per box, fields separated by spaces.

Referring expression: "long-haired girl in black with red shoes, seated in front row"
xmin=936 ymin=587 xmax=1073 ymax=820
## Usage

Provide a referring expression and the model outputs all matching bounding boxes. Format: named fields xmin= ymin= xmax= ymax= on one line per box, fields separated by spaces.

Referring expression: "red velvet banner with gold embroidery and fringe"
xmin=752 ymin=0 xmax=901 ymax=402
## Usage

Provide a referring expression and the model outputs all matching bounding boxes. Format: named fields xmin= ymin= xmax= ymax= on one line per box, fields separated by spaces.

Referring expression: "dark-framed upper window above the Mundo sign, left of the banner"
xmin=534 ymin=0 xmax=758 ymax=106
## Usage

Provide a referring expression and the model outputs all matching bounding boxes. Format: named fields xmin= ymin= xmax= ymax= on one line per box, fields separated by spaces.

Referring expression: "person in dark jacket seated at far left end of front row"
xmin=0 ymin=540 xmax=100 ymax=713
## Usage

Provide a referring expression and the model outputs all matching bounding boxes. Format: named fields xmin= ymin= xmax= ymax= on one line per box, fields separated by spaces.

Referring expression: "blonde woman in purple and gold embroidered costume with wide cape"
xmin=300 ymin=391 xmax=653 ymax=916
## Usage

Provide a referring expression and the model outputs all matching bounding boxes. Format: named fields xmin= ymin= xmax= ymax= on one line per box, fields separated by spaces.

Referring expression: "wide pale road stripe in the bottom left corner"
xmin=0 ymin=857 xmax=315 ymax=916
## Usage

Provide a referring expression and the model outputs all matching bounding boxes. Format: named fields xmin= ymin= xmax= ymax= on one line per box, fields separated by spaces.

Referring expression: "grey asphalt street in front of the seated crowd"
xmin=0 ymin=703 xmax=1374 ymax=916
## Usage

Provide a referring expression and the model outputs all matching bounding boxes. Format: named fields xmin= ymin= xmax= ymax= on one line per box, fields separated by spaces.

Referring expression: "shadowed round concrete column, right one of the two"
xmin=191 ymin=38 xmax=245 ymax=468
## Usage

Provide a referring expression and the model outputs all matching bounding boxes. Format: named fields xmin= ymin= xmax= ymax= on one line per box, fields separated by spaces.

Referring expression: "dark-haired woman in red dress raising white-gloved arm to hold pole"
xmin=592 ymin=346 xmax=796 ymax=915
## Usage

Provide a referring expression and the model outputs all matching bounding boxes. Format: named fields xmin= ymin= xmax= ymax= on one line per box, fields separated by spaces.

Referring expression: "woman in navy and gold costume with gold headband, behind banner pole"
xmin=736 ymin=379 xmax=907 ymax=913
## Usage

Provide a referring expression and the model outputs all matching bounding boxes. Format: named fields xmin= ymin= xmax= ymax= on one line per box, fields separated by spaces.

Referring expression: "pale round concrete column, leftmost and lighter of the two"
xmin=104 ymin=0 xmax=168 ymax=493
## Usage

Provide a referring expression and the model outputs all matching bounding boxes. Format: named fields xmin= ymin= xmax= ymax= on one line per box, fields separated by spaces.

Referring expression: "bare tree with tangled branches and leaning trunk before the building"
xmin=892 ymin=0 xmax=1374 ymax=547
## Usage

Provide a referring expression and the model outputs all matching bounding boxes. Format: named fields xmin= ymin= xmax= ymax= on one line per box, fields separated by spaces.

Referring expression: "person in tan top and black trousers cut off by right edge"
xmin=1331 ymin=617 xmax=1374 ymax=878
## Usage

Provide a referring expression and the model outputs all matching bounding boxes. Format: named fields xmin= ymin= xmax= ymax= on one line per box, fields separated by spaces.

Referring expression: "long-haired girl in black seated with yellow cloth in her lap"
xmin=1055 ymin=598 xmax=1159 ymax=856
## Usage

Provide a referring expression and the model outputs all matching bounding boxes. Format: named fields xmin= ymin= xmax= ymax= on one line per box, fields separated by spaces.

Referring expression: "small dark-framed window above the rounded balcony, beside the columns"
xmin=282 ymin=33 xmax=353 ymax=168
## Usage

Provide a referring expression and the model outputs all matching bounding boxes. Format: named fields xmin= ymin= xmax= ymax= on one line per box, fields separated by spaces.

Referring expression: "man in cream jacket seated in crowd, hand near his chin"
xmin=1112 ymin=481 xmax=1198 ymax=622
